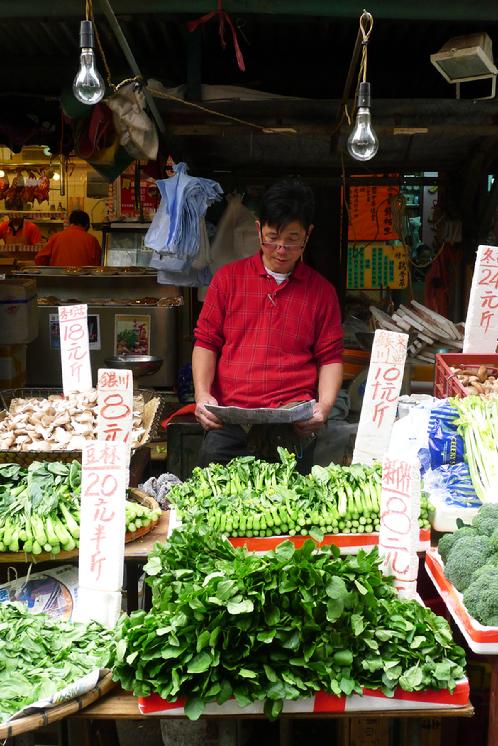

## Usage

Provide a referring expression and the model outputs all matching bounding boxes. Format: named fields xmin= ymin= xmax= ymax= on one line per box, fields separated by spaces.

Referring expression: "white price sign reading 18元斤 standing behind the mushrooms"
xmin=59 ymin=304 xmax=92 ymax=395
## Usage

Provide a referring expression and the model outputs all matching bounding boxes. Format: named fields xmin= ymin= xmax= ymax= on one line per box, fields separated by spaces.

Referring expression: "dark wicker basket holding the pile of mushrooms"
xmin=0 ymin=388 xmax=164 ymax=466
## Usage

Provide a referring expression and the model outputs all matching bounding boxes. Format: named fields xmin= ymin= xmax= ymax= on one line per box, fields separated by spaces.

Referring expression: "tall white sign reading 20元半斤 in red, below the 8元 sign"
xmin=76 ymin=440 xmax=129 ymax=625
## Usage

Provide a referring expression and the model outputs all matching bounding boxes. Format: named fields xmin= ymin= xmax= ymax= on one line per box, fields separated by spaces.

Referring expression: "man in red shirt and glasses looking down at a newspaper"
xmin=192 ymin=180 xmax=343 ymax=472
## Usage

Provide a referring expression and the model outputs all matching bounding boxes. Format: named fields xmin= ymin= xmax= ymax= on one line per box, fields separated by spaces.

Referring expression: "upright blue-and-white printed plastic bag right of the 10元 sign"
xmin=428 ymin=399 xmax=465 ymax=469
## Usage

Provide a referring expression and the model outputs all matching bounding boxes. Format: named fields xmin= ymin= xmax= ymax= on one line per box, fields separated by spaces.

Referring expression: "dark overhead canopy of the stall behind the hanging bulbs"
xmin=0 ymin=0 xmax=498 ymax=174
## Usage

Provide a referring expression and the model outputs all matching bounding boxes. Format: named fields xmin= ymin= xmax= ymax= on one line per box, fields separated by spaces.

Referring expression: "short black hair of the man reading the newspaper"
xmin=259 ymin=179 xmax=315 ymax=231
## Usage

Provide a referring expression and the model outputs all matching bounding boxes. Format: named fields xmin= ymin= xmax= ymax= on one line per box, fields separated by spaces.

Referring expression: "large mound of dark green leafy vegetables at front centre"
xmin=113 ymin=527 xmax=465 ymax=718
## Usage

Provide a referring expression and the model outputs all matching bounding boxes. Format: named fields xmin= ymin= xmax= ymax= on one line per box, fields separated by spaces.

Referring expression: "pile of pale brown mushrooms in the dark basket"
xmin=0 ymin=391 xmax=146 ymax=451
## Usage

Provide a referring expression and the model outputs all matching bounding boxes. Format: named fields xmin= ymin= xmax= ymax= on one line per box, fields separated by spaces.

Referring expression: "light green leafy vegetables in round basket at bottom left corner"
xmin=0 ymin=603 xmax=113 ymax=722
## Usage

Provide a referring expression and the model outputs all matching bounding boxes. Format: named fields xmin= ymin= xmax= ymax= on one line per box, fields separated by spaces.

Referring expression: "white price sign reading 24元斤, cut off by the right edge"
xmin=463 ymin=246 xmax=498 ymax=353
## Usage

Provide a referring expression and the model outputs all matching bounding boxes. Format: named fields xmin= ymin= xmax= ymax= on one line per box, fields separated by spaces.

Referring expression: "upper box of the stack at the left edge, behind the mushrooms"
xmin=0 ymin=277 xmax=38 ymax=345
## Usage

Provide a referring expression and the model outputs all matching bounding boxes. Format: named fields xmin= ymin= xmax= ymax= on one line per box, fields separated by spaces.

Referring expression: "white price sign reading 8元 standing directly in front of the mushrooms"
xmin=97 ymin=368 xmax=133 ymax=444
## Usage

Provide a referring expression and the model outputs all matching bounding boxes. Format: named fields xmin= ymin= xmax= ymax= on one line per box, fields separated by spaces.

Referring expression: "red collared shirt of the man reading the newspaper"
xmin=195 ymin=254 xmax=343 ymax=407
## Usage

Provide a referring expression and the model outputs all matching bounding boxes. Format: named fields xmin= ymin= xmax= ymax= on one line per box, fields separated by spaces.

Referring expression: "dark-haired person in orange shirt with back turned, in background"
xmin=35 ymin=210 xmax=102 ymax=267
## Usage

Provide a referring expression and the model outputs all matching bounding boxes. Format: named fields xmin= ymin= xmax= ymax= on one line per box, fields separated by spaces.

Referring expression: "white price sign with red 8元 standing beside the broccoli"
xmin=379 ymin=456 xmax=420 ymax=598
